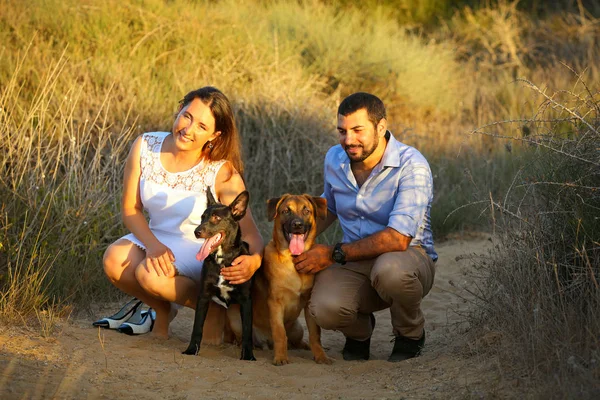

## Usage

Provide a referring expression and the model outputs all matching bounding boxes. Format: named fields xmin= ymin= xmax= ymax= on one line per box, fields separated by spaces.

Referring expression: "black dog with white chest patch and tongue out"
xmin=183 ymin=189 xmax=256 ymax=361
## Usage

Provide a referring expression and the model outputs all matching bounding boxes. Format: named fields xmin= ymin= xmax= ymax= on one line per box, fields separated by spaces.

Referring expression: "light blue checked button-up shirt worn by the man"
xmin=322 ymin=131 xmax=438 ymax=261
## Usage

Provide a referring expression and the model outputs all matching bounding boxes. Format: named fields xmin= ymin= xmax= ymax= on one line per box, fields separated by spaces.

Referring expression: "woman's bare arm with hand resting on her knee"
xmin=121 ymin=137 xmax=175 ymax=276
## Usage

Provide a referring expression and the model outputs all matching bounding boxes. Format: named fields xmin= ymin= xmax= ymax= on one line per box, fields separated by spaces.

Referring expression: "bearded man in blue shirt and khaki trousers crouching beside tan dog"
xmin=294 ymin=93 xmax=437 ymax=361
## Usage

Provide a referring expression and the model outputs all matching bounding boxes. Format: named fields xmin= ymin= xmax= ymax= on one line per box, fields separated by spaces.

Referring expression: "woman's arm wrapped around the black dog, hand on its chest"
xmin=215 ymin=162 xmax=265 ymax=285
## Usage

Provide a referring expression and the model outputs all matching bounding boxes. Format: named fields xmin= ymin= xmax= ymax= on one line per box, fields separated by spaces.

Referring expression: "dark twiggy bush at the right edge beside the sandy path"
xmin=473 ymin=68 xmax=600 ymax=398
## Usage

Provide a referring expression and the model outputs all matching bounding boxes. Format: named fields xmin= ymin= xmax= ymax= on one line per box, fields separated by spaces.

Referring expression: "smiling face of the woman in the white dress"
xmin=173 ymin=98 xmax=221 ymax=151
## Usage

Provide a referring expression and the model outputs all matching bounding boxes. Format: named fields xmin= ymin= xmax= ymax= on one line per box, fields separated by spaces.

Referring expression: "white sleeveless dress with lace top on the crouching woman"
xmin=122 ymin=132 xmax=225 ymax=282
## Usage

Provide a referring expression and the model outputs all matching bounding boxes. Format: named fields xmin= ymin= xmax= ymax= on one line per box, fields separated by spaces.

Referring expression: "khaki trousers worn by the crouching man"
xmin=309 ymin=246 xmax=435 ymax=340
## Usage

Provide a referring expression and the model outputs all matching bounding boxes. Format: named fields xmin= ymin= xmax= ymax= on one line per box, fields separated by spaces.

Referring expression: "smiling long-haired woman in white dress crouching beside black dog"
xmin=104 ymin=87 xmax=264 ymax=341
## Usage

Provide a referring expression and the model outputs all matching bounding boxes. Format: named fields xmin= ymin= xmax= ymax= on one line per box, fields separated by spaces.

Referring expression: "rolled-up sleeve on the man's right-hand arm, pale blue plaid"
xmin=387 ymin=164 xmax=433 ymax=238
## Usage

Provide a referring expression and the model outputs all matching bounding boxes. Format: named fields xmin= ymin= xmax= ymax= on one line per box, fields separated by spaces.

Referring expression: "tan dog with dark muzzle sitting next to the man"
xmin=232 ymin=194 xmax=332 ymax=365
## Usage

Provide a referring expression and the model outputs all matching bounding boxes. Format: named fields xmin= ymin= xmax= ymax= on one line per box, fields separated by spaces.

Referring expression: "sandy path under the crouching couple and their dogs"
xmin=0 ymin=235 xmax=510 ymax=399
